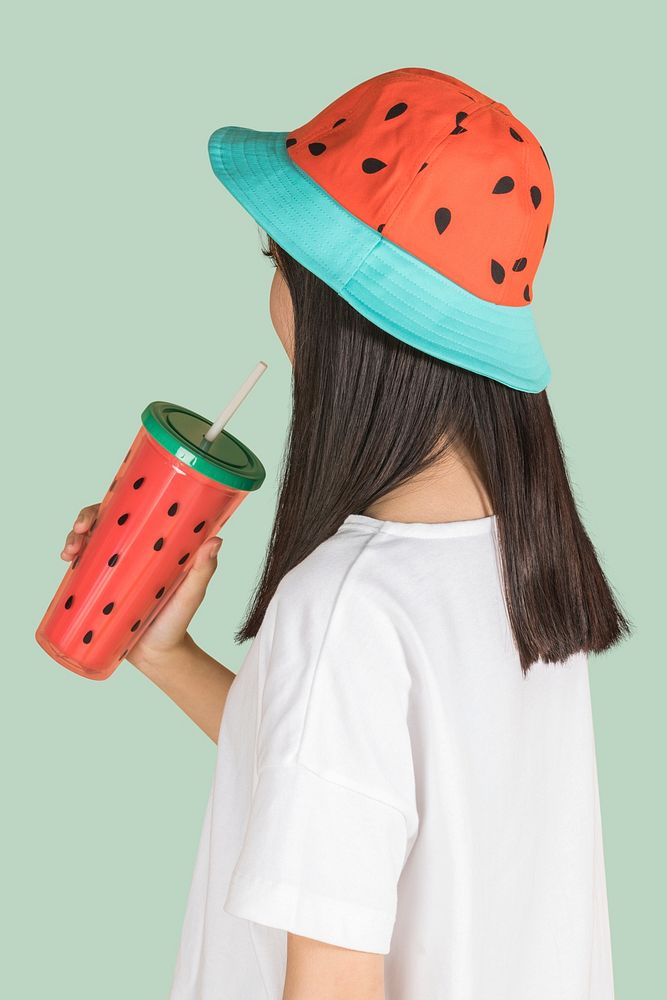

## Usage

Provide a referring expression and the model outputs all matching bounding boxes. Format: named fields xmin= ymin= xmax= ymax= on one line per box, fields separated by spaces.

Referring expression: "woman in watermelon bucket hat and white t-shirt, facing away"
xmin=63 ymin=68 xmax=629 ymax=1000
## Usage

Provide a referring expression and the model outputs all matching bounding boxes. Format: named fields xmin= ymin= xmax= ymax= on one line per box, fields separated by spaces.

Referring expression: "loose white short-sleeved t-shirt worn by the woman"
xmin=170 ymin=514 xmax=613 ymax=1000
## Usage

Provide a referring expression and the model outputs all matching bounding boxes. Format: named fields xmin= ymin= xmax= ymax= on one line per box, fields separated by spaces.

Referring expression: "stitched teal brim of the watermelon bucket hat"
xmin=208 ymin=125 xmax=551 ymax=392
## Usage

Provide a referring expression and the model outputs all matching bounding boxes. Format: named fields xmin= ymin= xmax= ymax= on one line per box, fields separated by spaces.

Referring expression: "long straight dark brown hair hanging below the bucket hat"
xmin=235 ymin=230 xmax=631 ymax=674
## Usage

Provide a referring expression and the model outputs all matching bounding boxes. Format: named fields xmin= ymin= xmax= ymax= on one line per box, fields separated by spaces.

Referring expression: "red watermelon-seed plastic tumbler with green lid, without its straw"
xmin=35 ymin=402 xmax=266 ymax=680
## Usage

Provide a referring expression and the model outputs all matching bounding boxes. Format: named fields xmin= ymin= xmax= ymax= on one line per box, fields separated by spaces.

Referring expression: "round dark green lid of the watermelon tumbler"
xmin=141 ymin=402 xmax=266 ymax=492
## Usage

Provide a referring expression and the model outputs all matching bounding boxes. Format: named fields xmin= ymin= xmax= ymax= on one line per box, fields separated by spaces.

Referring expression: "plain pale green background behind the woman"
xmin=0 ymin=0 xmax=667 ymax=1000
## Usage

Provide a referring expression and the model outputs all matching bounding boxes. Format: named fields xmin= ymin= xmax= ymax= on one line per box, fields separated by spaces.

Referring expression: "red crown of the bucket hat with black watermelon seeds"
xmin=286 ymin=68 xmax=554 ymax=306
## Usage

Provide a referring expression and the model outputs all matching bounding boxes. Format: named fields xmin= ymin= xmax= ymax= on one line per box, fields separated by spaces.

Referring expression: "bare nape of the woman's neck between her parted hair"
xmin=362 ymin=449 xmax=494 ymax=523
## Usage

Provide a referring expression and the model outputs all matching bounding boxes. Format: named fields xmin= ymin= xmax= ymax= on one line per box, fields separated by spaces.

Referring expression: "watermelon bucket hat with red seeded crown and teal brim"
xmin=208 ymin=67 xmax=554 ymax=392
